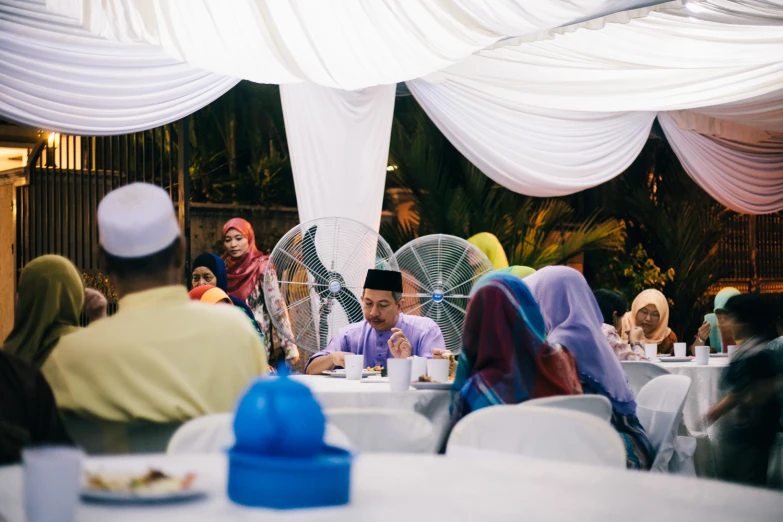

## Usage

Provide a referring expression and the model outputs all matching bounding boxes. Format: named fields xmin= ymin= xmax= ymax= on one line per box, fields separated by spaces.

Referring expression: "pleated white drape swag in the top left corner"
xmin=0 ymin=0 xmax=238 ymax=135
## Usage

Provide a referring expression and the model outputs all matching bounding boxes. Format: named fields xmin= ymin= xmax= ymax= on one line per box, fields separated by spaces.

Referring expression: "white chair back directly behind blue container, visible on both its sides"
xmin=166 ymin=413 xmax=353 ymax=455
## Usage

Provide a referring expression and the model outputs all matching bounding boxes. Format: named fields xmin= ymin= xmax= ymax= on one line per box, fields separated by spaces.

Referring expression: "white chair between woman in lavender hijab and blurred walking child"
xmin=636 ymin=375 xmax=696 ymax=475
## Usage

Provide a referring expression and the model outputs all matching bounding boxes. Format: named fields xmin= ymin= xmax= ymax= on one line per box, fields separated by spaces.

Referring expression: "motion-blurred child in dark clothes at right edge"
xmin=706 ymin=294 xmax=781 ymax=486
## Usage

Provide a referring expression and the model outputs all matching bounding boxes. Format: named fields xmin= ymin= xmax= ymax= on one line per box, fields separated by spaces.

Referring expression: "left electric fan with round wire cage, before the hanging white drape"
xmin=264 ymin=217 xmax=397 ymax=352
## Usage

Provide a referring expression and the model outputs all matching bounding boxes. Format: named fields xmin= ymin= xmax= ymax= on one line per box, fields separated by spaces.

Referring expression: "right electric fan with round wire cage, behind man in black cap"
xmin=394 ymin=234 xmax=493 ymax=353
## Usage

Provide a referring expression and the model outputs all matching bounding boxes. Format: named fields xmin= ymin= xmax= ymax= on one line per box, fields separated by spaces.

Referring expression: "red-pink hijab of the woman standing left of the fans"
xmin=223 ymin=218 xmax=269 ymax=301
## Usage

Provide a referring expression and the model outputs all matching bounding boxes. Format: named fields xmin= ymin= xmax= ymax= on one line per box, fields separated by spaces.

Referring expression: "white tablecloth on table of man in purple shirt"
xmin=291 ymin=375 xmax=451 ymax=447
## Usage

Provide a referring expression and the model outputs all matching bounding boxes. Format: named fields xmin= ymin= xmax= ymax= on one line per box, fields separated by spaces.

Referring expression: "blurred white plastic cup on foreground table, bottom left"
xmin=22 ymin=446 xmax=82 ymax=522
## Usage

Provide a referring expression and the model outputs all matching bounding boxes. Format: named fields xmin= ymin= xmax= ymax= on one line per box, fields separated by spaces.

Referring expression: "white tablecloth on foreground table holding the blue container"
xmin=0 ymin=454 xmax=783 ymax=522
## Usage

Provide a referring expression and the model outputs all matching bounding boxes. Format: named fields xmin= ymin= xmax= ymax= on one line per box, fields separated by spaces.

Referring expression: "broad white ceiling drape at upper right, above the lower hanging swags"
xmin=422 ymin=0 xmax=783 ymax=111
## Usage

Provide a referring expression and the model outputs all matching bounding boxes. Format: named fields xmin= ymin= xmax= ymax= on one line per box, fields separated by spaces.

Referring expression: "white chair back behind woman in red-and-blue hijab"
xmin=446 ymin=405 xmax=626 ymax=469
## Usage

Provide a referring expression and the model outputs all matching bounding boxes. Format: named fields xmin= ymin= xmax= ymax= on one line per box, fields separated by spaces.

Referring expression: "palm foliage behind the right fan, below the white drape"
xmin=381 ymin=99 xmax=624 ymax=268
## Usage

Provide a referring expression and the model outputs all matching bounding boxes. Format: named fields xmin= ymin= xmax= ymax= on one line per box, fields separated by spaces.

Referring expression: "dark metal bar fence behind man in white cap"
xmin=15 ymin=120 xmax=190 ymax=320
